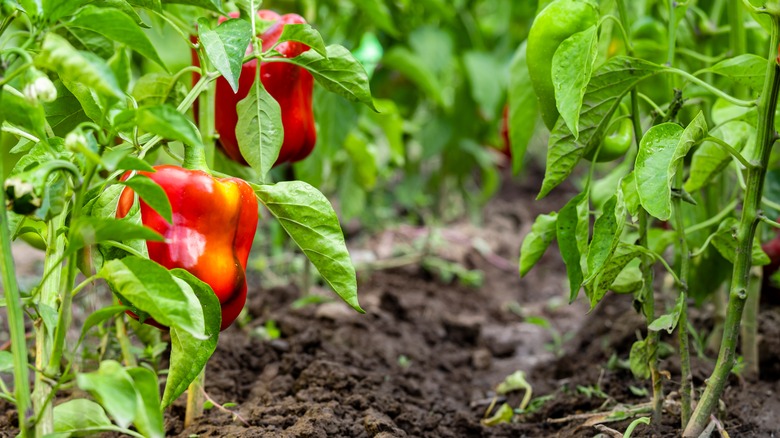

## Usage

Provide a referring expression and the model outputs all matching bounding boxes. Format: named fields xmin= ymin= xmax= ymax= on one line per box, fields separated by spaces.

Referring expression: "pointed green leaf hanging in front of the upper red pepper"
xmin=236 ymin=79 xmax=286 ymax=181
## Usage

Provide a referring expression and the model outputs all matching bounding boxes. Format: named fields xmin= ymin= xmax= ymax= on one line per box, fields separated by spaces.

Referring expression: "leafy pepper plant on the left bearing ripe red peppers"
xmin=0 ymin=0 xmax=373 ymax=437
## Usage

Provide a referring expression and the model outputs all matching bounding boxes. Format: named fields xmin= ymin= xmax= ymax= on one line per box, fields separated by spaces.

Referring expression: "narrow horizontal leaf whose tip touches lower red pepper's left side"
xmin=65 ymin=216 xmax=165 ymax=255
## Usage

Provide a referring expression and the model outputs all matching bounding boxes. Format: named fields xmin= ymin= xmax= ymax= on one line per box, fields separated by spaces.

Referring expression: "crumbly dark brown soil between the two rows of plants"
xmin=0 ymin=173 xmax=780 ymax=438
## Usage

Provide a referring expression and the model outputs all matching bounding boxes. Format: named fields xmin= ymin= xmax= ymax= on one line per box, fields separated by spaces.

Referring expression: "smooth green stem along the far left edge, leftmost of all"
xmin=0 ymin=125 xmax=32 ymax=438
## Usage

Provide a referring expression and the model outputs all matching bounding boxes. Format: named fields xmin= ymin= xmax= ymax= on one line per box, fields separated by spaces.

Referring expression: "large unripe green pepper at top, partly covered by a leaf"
xmin=526 ymin=0 xmax=599 ymax=129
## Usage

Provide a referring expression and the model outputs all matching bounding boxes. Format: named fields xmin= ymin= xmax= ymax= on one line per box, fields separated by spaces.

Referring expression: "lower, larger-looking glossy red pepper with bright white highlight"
xmin=116 ymin=165 xmax=258 ymax=330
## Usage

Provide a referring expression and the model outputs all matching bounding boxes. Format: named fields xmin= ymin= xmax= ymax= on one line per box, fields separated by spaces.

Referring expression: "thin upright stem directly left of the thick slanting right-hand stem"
xmin=672 ymin=162 xmax=693 ymax=428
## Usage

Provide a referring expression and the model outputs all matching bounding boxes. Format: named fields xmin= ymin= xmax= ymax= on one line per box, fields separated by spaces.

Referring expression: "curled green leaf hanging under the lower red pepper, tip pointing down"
xmin=162 ymin=269 xmax=222 ymax=408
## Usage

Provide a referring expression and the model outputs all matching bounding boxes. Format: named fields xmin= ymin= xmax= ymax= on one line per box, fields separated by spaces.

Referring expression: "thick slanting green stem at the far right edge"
xmin=683 ymin=15 xmax=780 ymax=437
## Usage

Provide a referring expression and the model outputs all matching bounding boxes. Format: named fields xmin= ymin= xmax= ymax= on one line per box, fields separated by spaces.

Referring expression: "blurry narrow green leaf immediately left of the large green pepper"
xmin=509 ymin=41 xmax=539 ymax=175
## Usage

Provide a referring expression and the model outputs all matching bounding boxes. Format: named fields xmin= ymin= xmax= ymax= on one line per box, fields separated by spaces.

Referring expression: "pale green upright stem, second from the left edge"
xmin=32 ymin=209 xmax=67 ymax=436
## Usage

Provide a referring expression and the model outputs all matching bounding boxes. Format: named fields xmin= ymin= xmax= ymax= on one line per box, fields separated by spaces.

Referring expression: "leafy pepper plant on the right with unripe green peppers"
xmin=509 ymin=0 xmax=780 ymax=437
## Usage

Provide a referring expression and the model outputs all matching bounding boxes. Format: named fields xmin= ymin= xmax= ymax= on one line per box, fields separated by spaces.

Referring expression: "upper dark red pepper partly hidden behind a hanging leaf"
xmin=192 ymin=10 xmax=317 ymax=165
